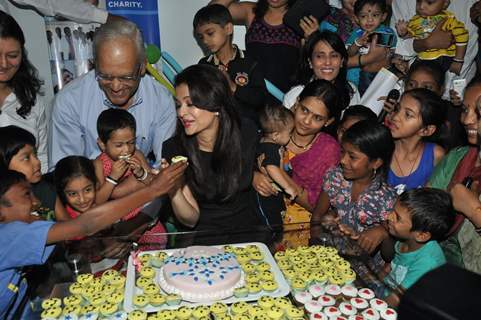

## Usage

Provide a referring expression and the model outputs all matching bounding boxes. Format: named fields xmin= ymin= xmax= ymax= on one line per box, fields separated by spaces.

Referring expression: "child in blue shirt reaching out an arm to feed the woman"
xmin=0 ymin=163 xmax=187 ymax=319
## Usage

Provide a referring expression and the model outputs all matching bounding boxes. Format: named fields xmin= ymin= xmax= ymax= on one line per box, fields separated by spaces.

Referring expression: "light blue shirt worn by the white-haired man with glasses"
xmin=48 ymin=70 xmax=177 ymax=170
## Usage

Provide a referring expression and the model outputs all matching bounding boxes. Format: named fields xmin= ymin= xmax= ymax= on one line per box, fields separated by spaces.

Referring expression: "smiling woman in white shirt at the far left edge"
xmin=0 ymin=11 xmax=48 ymax=172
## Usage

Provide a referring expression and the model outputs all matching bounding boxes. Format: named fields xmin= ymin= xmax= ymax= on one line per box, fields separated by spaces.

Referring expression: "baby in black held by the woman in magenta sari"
xmin=256 ymin=105 xmax=299 ymax=226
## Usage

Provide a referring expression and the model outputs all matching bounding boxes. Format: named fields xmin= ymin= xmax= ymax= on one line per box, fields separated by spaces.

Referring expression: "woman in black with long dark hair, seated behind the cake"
xmin=162 ymin=65 xmax=259 ymax=243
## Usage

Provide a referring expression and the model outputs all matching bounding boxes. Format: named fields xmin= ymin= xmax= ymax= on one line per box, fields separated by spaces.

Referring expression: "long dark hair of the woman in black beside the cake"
xmin=175 ymin=65 xmax=242 ymax=201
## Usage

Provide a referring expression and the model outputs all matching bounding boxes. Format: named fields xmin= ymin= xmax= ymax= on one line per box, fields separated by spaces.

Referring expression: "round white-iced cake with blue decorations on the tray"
xmin=158 ymin=246 xmax=244 ymax=302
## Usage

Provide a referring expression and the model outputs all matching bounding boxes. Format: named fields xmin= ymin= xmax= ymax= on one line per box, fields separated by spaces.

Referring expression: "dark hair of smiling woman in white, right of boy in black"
xmin=296 ymin=31 xmax=354 ymax=110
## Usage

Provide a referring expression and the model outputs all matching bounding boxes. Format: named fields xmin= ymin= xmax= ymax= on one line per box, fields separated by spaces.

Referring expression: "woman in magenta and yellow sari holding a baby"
xmin=266 ymin=80 xmax=340 ymax=247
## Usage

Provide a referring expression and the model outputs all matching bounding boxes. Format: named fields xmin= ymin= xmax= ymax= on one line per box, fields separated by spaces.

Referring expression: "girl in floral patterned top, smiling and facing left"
xmin=311 ymin=120 xmax=396 ymax=252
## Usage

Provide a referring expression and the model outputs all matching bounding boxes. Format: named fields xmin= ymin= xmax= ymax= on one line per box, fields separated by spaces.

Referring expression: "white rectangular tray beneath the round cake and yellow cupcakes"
xmin=124 ymin=242 xmax=290 ymax=312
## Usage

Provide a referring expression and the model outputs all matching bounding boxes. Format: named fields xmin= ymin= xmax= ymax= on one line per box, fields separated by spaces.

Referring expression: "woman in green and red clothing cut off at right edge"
xmin=429 ymin=78 xmax=481 ymax=273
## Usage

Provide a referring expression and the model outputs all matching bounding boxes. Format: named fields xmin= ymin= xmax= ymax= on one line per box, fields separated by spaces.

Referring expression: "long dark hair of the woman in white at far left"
xmin=0 ymin=11 xmax=42 ymax=118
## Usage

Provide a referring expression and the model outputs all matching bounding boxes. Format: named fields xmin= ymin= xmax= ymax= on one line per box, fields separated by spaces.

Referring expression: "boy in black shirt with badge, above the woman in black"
xmin=193 ymin=4 xmax=267 ymax=123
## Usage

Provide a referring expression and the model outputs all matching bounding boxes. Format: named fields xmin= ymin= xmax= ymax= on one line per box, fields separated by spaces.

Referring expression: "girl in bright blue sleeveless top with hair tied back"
xmin=387 ymin=88 xmax=446 ymax=194
